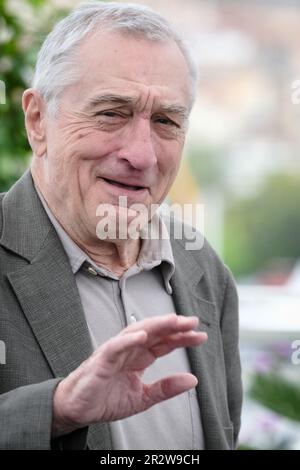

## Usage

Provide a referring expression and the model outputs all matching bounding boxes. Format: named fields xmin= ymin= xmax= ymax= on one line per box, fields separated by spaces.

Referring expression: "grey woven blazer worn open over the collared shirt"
xmin=0 ymin=171 xmax=242 ymax=450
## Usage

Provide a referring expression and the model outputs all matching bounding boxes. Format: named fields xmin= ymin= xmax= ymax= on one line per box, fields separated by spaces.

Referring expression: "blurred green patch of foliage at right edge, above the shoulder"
xmin=224 ymin=174 xmax=300 ymax=276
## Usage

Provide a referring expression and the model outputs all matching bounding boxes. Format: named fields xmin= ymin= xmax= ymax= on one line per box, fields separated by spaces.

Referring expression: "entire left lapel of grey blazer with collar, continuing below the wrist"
xmin=0 ymin=172 xmax=111 ymax=449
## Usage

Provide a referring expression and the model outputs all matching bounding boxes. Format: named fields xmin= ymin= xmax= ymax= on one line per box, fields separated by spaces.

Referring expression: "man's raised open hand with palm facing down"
xmin=53 ymin=314 xmax=207 ymax=437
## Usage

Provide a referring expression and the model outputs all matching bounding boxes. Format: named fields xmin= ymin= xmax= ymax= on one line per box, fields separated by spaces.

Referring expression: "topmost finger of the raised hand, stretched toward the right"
xmin=120 ymin=313 xmax=199 ymax=339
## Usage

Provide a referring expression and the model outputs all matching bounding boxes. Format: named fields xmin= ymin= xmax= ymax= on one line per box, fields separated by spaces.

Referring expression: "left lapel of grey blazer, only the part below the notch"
xmin=8 ymin=233 xmax=92 ymax=377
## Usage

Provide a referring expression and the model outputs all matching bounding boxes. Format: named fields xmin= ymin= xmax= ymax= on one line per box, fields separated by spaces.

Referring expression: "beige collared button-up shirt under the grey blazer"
xmin=38 ymin=191 xmax=204 ymax=450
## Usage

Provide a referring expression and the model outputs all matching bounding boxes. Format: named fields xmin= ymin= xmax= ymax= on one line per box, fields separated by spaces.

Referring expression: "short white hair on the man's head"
xmin=32 ymin=2 xmax=198 ymax=114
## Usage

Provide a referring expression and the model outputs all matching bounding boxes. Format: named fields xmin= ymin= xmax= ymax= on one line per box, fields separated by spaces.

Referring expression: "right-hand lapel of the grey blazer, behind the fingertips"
xmin=171 ymin=240 xmax=228 ymax=449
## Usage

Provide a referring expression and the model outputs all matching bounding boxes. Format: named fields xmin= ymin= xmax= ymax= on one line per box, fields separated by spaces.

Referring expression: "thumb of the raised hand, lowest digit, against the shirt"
xmin=143 ymin=373 xmax=198 ymax=410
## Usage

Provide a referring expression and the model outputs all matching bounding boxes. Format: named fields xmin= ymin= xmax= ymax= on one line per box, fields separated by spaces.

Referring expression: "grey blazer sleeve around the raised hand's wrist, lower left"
xmin=0 ymin=378 xmax=87 ymax=450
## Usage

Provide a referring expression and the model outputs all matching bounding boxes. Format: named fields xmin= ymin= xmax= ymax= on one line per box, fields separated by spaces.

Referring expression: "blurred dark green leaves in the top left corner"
xmin=0 ymin=0 xmax=65 ymax=192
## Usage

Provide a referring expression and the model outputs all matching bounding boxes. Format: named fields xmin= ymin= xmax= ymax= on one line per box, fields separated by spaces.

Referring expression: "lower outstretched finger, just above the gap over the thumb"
xmin=150 ymin=331 xmax=207 ymax=358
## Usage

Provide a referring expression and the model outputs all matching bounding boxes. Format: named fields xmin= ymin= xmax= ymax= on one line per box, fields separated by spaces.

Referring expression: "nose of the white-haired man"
xmin=119 ymin=117 xmax=157 ymax=170
